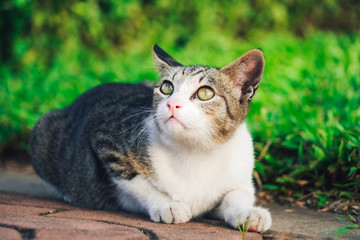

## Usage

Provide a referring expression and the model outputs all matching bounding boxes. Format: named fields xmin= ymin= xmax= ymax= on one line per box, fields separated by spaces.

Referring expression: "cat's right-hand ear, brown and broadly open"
xmin=220 ymin=49 xmax=265 ymax=103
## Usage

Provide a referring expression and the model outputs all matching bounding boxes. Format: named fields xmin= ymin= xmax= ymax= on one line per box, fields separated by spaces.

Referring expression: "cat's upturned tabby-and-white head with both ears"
xmin=153 ymin=45 xmax=265 ymax=149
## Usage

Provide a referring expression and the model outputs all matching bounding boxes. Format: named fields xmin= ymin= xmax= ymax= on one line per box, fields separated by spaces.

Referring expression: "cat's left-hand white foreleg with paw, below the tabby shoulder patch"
xmin=115 ymin=175 xmax=192 ymax=224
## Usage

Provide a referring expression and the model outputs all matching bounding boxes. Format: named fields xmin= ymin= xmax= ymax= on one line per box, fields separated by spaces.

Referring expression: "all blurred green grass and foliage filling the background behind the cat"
xmin=0 ymin=0 xmax=360 ymax=193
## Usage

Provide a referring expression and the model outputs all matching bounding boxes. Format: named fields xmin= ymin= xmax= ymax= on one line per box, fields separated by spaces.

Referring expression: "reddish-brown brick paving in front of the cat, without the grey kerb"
xmin=0 ymin=192 xmax=262 ymax=240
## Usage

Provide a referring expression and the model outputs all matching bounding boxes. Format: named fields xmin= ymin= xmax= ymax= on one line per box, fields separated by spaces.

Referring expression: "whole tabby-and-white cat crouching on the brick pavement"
xmin=30 ymin=45 xmax=272 ymax=232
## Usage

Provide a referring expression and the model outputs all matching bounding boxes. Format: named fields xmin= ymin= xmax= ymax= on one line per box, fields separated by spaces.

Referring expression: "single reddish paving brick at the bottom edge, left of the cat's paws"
xmin=0 ymin=205 xmax=148 ymax=239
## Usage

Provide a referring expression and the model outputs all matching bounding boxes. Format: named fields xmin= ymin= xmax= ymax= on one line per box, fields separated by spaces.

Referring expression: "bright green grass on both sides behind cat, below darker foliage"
xmin=0 ymin=32 xmax=360 ymax=195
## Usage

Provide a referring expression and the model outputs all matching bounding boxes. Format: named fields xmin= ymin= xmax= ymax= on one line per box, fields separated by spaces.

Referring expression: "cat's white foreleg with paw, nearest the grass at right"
xmin=214 ymin=190 xmax=271 ymax=232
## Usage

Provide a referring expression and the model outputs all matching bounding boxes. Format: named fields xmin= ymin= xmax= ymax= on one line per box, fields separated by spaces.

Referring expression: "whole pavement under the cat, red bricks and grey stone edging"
xmin=0 ymin=168 xmax=360 ymax=240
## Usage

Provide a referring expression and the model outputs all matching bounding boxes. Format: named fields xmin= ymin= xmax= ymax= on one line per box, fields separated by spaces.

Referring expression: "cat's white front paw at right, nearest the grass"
xmin=225 ymin=207 xmax=271 ymax=232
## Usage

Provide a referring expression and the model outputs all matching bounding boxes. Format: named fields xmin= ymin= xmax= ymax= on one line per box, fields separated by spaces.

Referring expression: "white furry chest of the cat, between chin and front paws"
xmin=151 ymin=124 xmax=254 ymax=216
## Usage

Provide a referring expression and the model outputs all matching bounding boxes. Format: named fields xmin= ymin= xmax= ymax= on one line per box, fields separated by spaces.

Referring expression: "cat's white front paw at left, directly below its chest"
xmin=149 ymin=202 xmax=191 ymax=224
